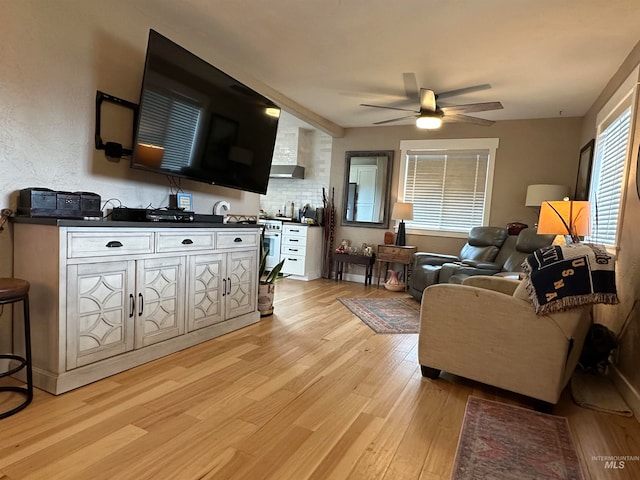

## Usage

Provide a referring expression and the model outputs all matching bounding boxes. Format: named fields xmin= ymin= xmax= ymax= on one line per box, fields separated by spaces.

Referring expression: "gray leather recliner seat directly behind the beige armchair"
xmin=438 ymin=228 xmax=555 ymax=283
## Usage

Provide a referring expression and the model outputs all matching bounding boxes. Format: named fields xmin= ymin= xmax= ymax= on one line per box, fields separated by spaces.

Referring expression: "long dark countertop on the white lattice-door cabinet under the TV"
xmin=11 ymin=217 xmax=260 ymax=228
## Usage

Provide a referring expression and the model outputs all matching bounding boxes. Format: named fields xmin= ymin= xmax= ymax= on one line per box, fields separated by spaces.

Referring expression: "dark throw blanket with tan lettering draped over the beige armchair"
xmin=522 ymin=243 xmax=618 ymax=315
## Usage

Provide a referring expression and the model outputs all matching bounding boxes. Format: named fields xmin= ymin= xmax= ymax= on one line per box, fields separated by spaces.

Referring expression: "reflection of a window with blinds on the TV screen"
xmin=138 ymin=90 xmax=202 ymax=172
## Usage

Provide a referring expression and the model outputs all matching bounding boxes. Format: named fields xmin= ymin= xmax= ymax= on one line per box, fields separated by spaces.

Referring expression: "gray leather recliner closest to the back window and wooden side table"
xmin=409 ymin=227 xmax=509 ymax=300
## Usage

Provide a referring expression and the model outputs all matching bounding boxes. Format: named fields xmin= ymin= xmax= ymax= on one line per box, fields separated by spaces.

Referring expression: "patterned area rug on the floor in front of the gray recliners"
xmin=338 ymin=297 xmax=420 ymax=333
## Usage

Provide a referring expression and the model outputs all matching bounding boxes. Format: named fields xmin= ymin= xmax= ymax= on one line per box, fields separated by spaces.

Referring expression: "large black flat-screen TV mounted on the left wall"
xmin=131 ymin=30 xmax=280 ymax=194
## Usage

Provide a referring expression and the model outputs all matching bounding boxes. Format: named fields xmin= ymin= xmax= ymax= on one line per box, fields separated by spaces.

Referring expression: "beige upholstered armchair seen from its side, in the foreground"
xmin=418 ymin=276 xmax=591 ymax=410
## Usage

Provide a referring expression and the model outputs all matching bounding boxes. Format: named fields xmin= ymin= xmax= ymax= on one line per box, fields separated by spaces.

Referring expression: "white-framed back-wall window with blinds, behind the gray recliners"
xmin=400 ymin=139 xmax=497 ymax=235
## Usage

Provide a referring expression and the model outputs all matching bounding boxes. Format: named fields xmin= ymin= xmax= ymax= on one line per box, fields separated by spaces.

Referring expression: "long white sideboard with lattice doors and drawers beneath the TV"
xmin=14 ymin=219 xmax=260 ymax=394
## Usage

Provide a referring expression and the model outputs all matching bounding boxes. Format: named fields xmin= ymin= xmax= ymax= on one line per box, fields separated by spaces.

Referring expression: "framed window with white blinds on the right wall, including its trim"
xmin=585 ymin=67 xmax=639 ymax=248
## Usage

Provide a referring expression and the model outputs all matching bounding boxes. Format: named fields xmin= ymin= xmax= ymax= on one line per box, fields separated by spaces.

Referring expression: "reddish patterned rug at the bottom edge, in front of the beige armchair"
xmin=451 ymin=396 xmax=584 ymax=480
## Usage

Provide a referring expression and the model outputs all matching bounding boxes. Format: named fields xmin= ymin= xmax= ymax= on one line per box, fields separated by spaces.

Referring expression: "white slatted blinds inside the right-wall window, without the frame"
xmin=587 ymin=106 xmax=631 ymax=247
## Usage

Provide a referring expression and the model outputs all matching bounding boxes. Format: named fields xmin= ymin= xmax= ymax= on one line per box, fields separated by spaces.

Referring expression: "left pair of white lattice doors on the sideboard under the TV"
xmin=67 ymin=257 xmax=185 ymax=369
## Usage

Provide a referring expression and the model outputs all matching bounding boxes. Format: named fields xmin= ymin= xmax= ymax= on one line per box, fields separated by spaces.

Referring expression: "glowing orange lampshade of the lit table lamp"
xmin=538 ymin=199 xmax=591 ymax=243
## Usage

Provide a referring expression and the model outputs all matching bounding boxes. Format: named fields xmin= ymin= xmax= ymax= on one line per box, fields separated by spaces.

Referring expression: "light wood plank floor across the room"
xmin=0 ymin=280 xmax=640 ymax=480
